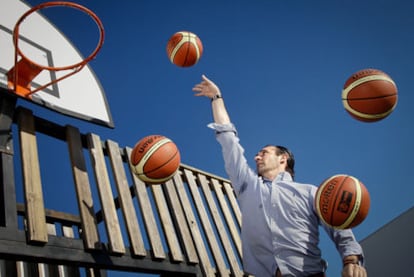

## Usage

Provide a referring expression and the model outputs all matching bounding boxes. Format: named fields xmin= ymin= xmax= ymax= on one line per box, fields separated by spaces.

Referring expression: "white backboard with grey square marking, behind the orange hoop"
xmin=0 ymin=0 xmax=114 ymax=128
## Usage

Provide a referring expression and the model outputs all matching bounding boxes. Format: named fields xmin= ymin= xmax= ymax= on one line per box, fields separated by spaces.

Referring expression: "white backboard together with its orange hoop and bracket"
xmin=0 ymin=0 xmax=114 ymax=128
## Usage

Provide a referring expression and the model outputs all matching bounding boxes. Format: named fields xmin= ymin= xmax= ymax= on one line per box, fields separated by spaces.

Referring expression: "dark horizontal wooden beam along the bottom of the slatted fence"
xmin=0 ymin=228 xmax=201 ymax=276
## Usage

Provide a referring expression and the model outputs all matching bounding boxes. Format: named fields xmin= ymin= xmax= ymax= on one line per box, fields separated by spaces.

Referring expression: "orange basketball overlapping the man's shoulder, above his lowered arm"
xmin=315 ymin=174 xmax=370 ymax=229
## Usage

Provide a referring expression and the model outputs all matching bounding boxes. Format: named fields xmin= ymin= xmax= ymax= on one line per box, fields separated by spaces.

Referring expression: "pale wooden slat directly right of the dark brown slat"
xmin=86 ymin=133 xmax=125 ymax=254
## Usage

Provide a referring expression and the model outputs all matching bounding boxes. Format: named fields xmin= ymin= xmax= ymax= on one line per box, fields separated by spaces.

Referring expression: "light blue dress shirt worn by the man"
xmin=209 ymin=123 xmax=363 ymax=277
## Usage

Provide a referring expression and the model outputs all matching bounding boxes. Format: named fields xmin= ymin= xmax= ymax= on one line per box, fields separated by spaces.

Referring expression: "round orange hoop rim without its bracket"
xmin=13 ymin=1 xmax=105 ymax=71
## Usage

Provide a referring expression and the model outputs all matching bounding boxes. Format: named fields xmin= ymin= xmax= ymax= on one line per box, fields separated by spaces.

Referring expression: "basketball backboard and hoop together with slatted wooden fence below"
xmin=0 ymin=0 xmax=245 ymax=277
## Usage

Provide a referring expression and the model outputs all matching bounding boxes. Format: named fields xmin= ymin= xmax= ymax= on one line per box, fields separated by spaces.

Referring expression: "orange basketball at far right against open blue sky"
xmin=342 ymin=69 xmax=398 ymax=122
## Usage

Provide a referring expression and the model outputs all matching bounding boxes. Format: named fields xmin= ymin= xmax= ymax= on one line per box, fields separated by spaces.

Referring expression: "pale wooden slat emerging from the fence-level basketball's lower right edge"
xmin=163 ymin=175 xmax=198 ymax=263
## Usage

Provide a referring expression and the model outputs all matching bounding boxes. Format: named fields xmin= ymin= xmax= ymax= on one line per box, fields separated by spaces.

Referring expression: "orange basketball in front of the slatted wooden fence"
xmin=130 ymin=135 xmax=180 ymax=184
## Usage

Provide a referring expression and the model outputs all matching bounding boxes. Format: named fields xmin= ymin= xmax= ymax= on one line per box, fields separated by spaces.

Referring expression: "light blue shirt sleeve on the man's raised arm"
xmin=208 ymin=123 xmax=257 ymax=195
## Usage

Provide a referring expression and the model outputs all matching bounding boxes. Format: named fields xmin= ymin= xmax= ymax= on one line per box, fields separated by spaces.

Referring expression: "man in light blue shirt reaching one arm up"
xmin=193 ymin=75 xmax=367 ymax=277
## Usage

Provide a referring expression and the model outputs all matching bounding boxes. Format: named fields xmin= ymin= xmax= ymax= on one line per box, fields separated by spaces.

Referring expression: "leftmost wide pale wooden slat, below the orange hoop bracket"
xmin=18 ymin=109 xmax=48 ymax=243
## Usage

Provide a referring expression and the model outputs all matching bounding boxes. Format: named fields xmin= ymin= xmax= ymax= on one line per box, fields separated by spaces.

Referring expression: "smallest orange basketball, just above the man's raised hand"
xmin=167 ymin=31 xmax=203 ymax=67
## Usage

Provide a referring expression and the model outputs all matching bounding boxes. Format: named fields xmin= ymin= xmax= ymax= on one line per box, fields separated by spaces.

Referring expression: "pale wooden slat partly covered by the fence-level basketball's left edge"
xmin=125 ymin=147 xmax=166 ymax=259
